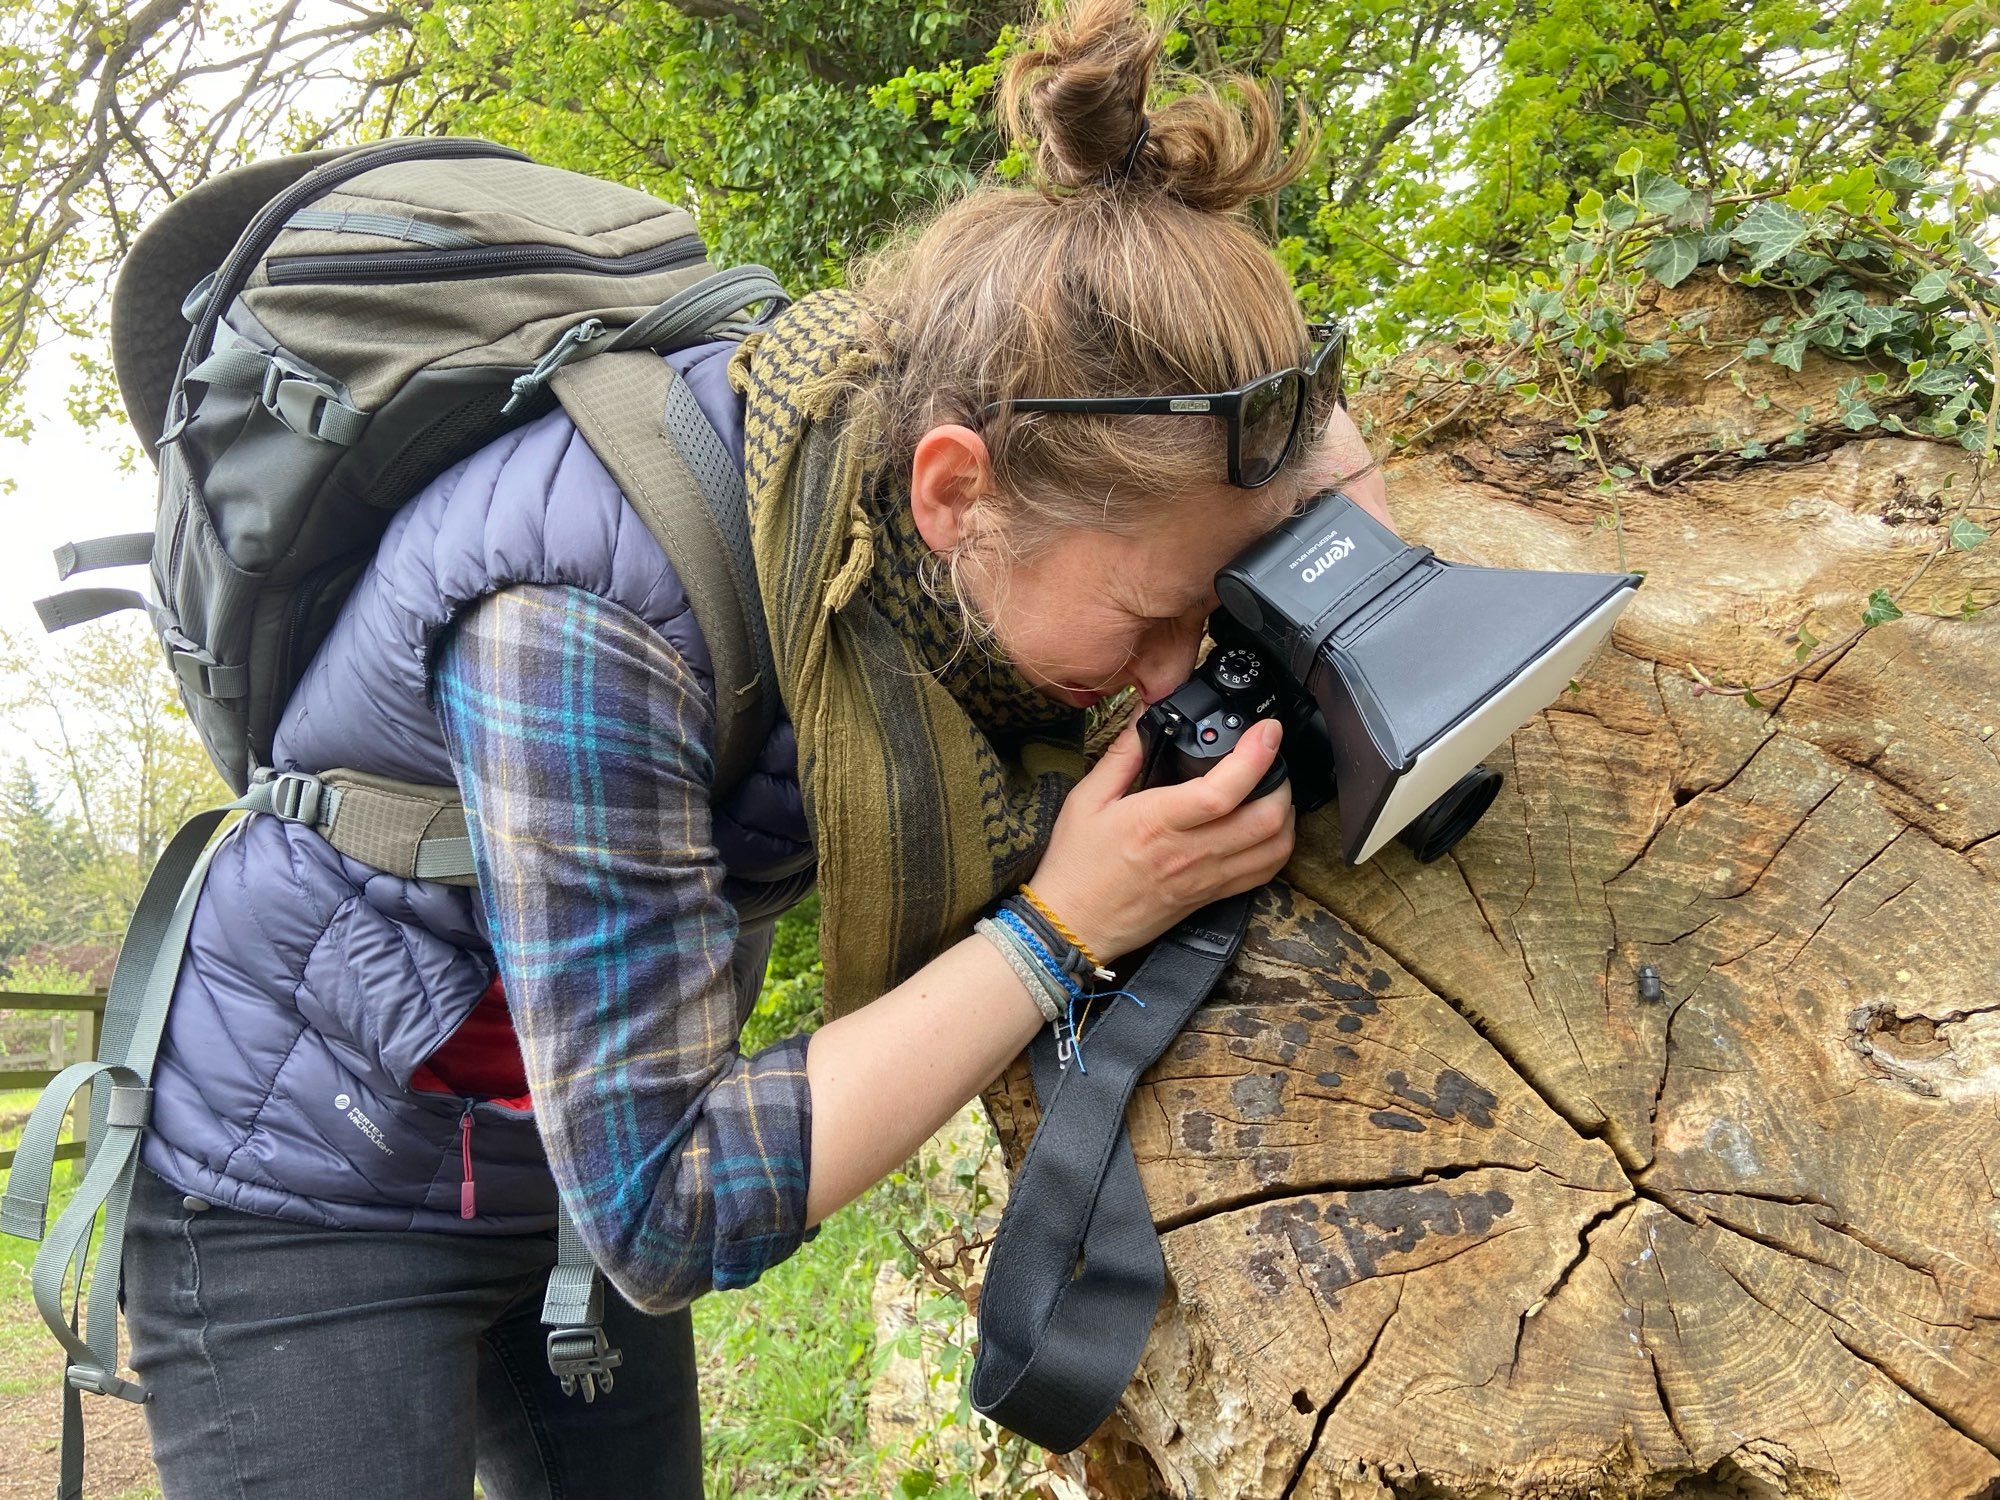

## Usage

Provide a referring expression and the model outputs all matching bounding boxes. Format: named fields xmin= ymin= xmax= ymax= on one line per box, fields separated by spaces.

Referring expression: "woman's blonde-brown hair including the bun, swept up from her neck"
xmin=852 ymin=0 xmax=1312 ymax=572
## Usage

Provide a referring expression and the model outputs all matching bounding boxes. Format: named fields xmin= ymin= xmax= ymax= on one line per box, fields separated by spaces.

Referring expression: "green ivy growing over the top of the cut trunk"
xmin=1396 ymin=150 xmax=2000 ymax=708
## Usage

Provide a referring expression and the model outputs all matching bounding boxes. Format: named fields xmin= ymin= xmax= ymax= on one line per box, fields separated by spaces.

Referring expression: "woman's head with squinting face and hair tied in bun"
xmin=856 ymin=0 xmax=1318 ymax=702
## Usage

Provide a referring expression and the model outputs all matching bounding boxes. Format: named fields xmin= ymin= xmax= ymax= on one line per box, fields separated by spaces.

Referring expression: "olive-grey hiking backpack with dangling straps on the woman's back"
xmin=0 ymin=138 xmax=810 ymax=1496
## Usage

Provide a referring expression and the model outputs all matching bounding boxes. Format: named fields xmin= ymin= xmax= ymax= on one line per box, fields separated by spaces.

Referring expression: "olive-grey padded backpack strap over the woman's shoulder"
xmin=554 ymin=350 xmax=778 ymax=790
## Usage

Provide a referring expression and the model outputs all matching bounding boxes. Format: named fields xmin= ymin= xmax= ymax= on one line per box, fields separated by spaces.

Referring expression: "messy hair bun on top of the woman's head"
xmin=1000 ymin=0 xmax=1304 ymax=214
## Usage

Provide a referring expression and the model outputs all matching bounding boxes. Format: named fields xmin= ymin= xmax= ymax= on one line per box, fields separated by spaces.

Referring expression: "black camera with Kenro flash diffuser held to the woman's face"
xmin=1138 ymin=490 xmax=1644 ymax=864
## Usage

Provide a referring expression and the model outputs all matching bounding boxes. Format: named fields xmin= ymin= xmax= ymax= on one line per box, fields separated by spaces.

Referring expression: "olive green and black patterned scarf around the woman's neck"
xmin=730 ymin=292 xmax=1086 ymax=1016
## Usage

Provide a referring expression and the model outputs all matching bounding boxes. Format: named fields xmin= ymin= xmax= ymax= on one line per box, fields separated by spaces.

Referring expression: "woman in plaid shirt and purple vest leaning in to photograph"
xmin=113 ymin=0 xmax=1382 ymax=1500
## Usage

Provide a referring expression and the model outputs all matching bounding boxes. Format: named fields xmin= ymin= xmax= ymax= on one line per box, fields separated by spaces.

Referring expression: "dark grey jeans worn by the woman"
xmin=124 ymin=1166 xmax=702 ymax=1500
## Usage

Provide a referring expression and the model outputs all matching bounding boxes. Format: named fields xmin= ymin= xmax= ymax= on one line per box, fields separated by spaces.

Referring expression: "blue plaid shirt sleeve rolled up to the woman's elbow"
xmin=430 ymin=584 xmax=812 ymax=1312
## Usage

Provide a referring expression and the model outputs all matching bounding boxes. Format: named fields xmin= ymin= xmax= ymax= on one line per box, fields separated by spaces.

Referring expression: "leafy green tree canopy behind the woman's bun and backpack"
xmin=0 ymin=0 xmax=2000 ymax=410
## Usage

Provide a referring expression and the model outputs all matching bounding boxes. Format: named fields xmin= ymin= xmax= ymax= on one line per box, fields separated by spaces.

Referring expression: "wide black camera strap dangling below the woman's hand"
xmin=972 ymin=892 xmax=1250 ymax=1452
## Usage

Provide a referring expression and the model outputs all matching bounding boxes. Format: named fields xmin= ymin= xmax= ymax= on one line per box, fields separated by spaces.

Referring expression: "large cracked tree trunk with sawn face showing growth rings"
xmin=990 ymin=278 xmax=2000 ymax=1500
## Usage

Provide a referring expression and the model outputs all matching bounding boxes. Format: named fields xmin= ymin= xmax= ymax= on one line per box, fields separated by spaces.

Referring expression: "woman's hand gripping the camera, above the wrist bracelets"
xmin=1030 ymin=718 xmax=1296 ymax=962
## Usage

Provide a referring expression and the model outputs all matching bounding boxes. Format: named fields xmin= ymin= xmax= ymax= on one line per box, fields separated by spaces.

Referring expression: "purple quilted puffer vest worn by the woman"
xmin=142 ymin=344 xmax=808 ymax=1234
